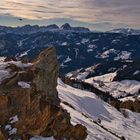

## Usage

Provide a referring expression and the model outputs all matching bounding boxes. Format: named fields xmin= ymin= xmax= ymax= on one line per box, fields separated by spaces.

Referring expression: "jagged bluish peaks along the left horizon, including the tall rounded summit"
xmin=0 ymin=23 xmax=90 ymax=34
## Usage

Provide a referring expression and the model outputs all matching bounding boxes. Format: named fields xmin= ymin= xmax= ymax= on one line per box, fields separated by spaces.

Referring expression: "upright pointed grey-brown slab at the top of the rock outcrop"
xmin=33 ymin=48 xmax=59 ymax=103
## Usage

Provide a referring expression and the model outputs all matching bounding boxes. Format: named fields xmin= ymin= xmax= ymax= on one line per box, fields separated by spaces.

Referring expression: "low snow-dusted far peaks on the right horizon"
xmin=108 ymin=28 xmax=140 ymax=35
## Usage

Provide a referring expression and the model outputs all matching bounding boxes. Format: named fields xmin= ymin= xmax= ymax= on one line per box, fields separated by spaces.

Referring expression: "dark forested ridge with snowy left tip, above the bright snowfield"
xmin=65 ymin=59 xmax=140 ymax=81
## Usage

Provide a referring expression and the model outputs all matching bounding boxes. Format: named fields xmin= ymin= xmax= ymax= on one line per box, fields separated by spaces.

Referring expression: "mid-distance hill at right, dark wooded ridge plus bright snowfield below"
xmin=65 ymin=63 xmax=140 ymax=101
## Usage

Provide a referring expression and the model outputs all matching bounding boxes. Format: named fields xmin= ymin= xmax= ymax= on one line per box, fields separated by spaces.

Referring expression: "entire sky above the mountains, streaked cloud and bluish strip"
xmin=0 ymin=0 xmax=140 ymax=30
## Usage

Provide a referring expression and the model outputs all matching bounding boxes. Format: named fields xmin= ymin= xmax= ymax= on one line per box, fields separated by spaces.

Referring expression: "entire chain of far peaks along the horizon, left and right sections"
xmin=0 ymin=23 xmax=140 ymax=35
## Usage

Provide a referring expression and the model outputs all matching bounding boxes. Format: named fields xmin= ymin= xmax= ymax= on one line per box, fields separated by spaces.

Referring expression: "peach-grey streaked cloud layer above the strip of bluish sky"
xmin=0 ymin=0 xmax=140 ymax=26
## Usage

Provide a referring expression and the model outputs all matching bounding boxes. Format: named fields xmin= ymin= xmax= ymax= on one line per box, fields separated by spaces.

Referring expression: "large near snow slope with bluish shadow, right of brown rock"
xmin=57 ymin=80 xmax=140 ymax=140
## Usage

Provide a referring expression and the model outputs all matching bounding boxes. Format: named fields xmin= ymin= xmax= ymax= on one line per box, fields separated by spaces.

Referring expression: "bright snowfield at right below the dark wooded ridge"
xmin=84 ymin=72 xmax=140 ymax=101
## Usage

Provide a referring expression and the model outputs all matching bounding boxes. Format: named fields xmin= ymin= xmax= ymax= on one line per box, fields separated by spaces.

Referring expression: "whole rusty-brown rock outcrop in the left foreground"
xmin=0 ymin=48 xmax=87 ymax=140
